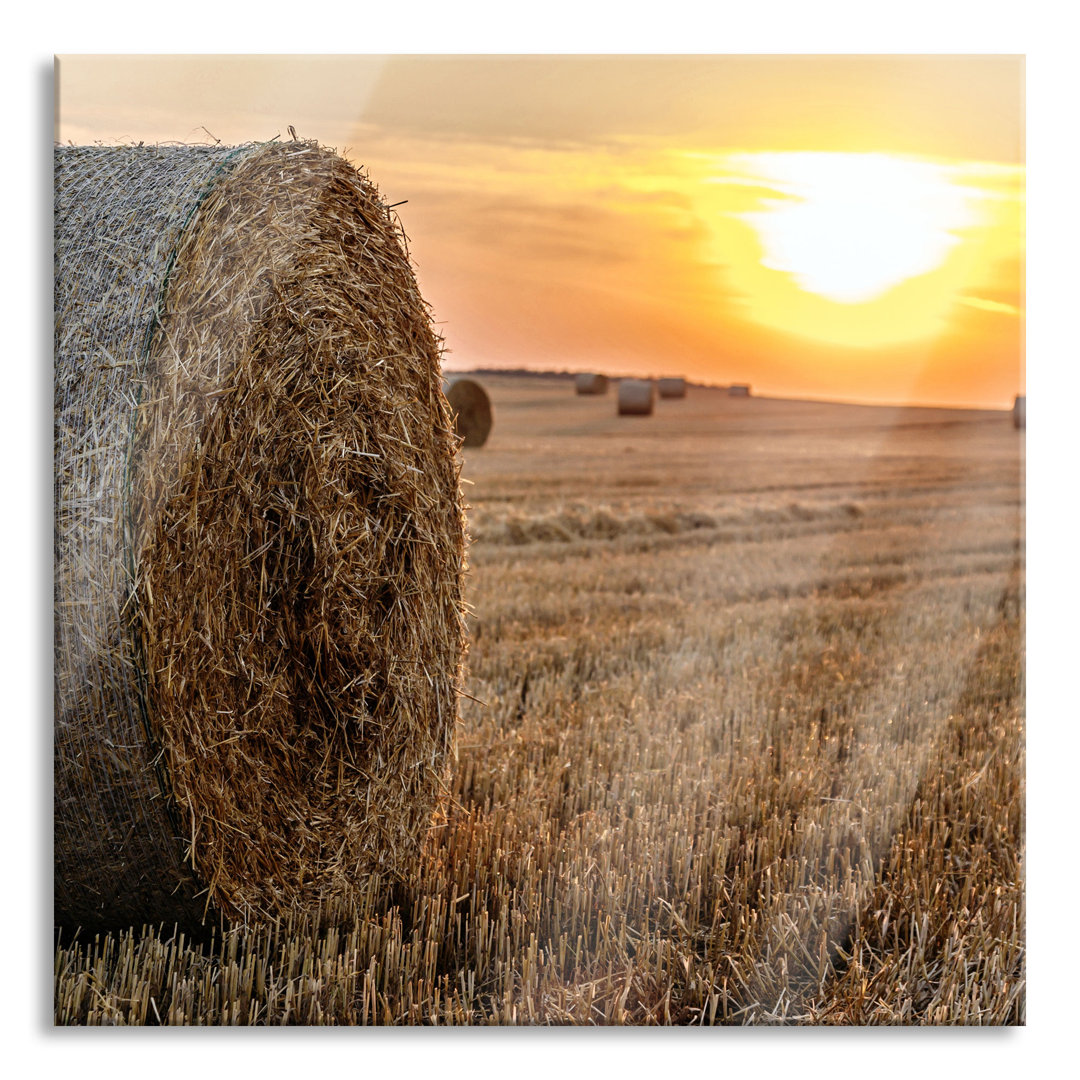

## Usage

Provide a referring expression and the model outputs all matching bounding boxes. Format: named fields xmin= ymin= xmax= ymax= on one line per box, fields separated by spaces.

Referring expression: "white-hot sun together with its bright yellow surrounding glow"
xmin=697 ymin=151 xmax=1023 ymax=349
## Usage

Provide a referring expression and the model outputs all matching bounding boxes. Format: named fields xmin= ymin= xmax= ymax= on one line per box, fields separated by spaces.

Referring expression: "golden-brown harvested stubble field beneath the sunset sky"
xmin=55 ymin=377 xmax=1026 ymax=1025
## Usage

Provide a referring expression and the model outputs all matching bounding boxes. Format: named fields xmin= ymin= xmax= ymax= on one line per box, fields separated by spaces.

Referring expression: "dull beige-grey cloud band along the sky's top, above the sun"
xmin=352 ymin=55 xmax=1023 ymax=161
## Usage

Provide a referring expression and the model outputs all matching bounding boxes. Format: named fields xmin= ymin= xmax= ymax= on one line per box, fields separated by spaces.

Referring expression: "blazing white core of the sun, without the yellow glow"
xmin=733 ymin=152 xmax=974 ymax=303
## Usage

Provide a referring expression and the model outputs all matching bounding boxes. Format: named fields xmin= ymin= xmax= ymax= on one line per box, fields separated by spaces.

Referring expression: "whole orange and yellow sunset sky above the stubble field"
xmin=56 ymin=55 xmax=1025 ymax=407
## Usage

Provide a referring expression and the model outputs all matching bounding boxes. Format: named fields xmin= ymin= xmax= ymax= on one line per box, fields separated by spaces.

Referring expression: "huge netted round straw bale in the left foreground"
xmin=54 ymin=141 xmax=464 ymax=929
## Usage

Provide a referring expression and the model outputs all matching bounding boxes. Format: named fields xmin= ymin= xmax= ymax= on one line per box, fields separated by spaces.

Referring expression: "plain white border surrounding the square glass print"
xmin=8 ymin=0 xmax=1080 ymax=1080
